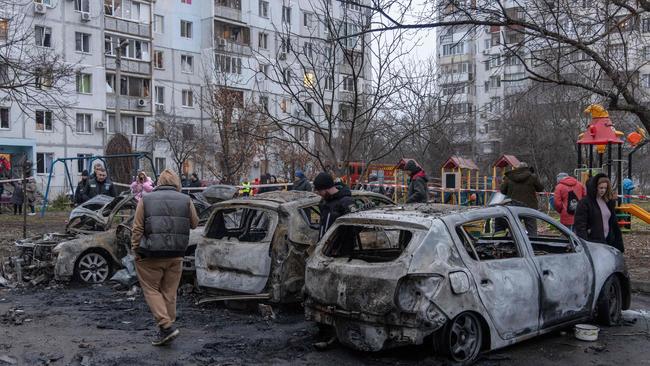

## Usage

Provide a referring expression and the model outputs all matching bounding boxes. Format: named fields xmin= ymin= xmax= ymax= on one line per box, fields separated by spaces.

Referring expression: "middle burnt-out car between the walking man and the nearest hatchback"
xmin=195 ymin=191 xmax=393 ymax=303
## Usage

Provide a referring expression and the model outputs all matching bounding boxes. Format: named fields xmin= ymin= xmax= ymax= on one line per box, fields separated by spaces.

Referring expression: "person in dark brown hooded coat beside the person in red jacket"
xmin=499 ymin=162 xmax=544 ymax=236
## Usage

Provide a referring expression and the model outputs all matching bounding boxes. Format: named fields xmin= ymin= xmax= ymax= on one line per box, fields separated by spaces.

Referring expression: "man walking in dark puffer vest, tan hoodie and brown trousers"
xmin=131 ymin=169 xmax=199 ymax=346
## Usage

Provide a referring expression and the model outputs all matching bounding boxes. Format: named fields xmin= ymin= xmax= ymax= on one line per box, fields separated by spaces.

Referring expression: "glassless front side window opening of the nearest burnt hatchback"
xmin=519 ymin=215 xmax=575 ymax=256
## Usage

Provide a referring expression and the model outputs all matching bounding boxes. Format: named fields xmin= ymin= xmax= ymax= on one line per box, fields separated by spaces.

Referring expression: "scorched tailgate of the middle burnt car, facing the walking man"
xmin=195 ymin=206 xmax=278 ymax=294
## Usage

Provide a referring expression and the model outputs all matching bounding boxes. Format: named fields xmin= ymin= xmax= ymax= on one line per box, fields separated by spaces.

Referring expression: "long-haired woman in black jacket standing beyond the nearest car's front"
xmin=574 ymin=173 xmax=624 ymax=252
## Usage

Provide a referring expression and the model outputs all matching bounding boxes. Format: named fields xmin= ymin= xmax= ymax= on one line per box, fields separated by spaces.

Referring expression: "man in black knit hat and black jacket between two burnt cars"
xmin=314 ymin=172 xmax=355 ymax=239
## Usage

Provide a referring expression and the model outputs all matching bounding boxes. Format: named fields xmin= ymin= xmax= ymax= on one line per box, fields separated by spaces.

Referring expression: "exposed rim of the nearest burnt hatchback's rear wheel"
xmin=449 ymin=314 xmax=480 ymax=362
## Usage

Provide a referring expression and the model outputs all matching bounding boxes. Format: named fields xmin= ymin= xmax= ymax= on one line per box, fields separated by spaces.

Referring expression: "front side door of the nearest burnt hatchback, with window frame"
xmin=518 ymin=212 xmax=594 ymax=328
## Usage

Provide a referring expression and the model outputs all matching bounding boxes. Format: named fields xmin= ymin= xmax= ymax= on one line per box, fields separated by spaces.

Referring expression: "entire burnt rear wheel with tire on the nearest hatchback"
xmin=433 ymin=312 xmax=484 ymax=365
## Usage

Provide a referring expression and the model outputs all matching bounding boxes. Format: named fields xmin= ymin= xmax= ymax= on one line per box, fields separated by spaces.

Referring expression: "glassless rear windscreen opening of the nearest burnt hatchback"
xmin=323 ymin=225 xmax=413 ymax=263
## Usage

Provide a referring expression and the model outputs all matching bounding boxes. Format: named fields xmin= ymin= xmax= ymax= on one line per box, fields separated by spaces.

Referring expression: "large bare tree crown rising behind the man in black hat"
xmin=251 ymin=0 xmax=417 ymax=175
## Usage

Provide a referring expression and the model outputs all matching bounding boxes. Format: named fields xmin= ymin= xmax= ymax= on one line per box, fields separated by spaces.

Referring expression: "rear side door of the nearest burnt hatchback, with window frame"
xmin=455 ymin=211 xmax=539 ymax=339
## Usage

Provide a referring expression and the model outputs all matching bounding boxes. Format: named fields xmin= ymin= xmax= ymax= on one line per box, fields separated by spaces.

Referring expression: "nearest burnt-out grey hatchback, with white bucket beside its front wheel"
xmin=305 ymin=204 xmax=630 ymax=364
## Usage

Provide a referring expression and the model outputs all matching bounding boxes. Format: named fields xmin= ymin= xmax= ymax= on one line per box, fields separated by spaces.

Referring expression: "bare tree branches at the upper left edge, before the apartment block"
xmin=0 ymin=0 xmax=77 ymax=121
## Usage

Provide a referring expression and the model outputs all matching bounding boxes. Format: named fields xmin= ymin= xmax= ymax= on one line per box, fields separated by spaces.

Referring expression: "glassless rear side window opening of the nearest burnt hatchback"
xmin=456 ymin=216 xmax=521 ymax=261
